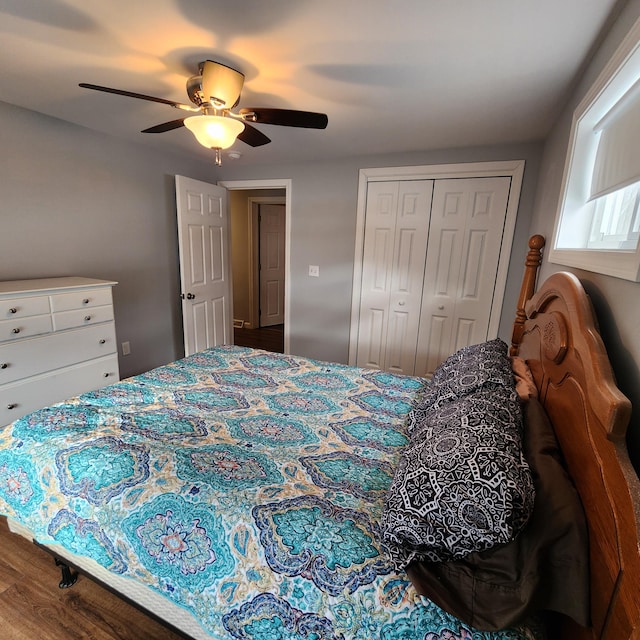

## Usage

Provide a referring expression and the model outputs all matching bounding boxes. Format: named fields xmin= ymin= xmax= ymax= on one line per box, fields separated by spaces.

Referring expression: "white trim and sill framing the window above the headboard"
xmin=548 ymin=14 xmax=640 ymax=282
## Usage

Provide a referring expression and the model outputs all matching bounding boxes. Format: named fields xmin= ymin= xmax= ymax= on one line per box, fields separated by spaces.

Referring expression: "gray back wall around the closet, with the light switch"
xmin=216 ymin=143 xmax=542 ymax=362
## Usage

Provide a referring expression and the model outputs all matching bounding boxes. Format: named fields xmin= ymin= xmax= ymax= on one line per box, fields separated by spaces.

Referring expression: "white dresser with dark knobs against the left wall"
xmin=0 ymin=278 xmax=120 ymax=425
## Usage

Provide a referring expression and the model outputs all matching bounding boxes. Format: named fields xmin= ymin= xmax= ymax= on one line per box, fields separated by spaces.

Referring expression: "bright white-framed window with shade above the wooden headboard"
xmin=549 ymin=13 xmax=640 ymax=282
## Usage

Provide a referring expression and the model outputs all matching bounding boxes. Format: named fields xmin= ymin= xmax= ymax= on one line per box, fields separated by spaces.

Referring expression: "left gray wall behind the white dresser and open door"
xmin=0 ymin=102 xmax=212 ymax=377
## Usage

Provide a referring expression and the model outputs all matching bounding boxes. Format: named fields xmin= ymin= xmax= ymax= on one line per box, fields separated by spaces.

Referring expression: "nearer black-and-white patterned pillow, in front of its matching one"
xmin=382 ymin=382 xmax=535 ymax=569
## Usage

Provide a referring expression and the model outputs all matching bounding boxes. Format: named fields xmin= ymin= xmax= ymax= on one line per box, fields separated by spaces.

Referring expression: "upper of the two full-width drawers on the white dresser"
xmin=0 ymin=322 xmax=117 ymax=386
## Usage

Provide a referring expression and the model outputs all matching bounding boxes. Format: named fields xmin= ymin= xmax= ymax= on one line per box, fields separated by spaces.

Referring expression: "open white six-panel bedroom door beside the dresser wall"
xmin=176 ymin=176 xmax=233 ymax=355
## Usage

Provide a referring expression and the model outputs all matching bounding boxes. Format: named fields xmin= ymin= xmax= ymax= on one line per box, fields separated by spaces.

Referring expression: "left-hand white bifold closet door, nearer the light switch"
xmin=356 ymin=180 xmax=433 ymax=374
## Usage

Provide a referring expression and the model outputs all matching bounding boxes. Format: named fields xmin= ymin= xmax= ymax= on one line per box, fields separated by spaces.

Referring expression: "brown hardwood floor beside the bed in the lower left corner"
xmin=0 ymin=517 xmax=184 ymax=640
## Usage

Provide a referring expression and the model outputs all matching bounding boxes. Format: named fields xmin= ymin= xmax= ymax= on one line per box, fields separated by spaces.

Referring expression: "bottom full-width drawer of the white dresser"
xmin=0 ymin=354 xmax=119 ymax=425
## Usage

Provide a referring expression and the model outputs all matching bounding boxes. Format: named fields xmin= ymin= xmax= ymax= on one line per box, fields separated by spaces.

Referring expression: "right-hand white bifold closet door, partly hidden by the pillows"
xmin=415 ymin=177 xmax=511 ymax=375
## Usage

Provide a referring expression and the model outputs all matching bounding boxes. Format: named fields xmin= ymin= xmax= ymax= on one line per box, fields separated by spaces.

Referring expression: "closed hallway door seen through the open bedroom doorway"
xmin=259 ymin=204 xmax=285 ymax=327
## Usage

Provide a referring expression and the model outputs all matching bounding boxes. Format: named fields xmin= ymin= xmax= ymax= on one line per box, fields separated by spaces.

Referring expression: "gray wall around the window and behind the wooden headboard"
xmin=530 ymin=0 xmax=640 ymax=470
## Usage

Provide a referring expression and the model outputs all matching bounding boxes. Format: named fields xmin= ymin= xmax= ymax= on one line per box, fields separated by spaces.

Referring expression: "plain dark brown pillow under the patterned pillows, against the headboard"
xmin=407 ymin=398 xmax=590 ymax=631
